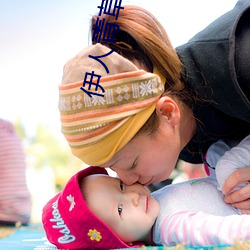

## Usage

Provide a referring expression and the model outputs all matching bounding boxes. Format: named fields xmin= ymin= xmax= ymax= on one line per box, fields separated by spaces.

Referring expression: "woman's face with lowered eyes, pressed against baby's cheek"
xmin=101 ymin=116 xmax=181 ymax=185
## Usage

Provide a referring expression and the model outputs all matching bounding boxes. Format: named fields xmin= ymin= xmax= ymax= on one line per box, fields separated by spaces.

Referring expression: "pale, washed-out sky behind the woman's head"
xmin=0 ymin=0 xmax=237 ymax=138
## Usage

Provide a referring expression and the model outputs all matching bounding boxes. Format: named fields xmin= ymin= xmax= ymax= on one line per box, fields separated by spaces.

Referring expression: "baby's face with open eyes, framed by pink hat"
xmin=85 ymin=175 xmax=160 ymax=243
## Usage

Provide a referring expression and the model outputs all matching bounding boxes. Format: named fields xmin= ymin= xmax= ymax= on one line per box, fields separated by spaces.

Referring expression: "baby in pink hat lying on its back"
xmin=42 ymin=136 xmax=250 ymax=249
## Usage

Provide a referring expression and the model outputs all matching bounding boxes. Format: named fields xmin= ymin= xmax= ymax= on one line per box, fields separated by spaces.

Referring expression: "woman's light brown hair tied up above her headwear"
xmin=91 ymin=5 xmax=190 ymax=134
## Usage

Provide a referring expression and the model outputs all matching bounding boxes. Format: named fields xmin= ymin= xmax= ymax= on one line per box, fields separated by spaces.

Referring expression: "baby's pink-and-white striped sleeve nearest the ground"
xmin=161 ymin=210 xmax=250 ymax=246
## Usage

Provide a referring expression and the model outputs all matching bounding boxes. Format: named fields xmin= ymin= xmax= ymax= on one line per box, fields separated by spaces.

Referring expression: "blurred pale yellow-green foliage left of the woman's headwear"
xmin=15 ymin=120 xmax=84 ymax=191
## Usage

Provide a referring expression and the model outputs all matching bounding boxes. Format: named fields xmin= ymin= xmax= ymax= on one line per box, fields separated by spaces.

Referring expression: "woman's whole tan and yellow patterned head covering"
xmin=59 ymin=44 xmax=165 ymax=166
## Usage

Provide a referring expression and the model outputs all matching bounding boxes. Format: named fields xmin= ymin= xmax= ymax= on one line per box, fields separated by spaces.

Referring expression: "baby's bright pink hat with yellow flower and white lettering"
xmin=42 ymin=167 xmax=142 ymax=249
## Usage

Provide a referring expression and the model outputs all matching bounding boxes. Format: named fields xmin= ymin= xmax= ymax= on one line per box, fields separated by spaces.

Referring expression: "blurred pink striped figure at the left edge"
xmin=0 ymin=119 xmax=31 ymax=223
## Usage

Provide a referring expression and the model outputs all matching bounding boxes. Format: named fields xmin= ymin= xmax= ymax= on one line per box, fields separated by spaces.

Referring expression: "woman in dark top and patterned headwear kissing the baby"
xmin=60 ymin=0 xmax=250 ymax=211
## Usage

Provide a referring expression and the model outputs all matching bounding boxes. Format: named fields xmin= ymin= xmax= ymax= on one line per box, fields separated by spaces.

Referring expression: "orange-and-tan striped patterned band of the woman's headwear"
xmin=59 ymin=70 xmax=164 ymax=147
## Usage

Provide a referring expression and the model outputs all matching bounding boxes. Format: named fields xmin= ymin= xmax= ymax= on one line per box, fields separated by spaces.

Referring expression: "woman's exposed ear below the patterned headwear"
xmin=156 ymin=96 xmax=180 ymax=126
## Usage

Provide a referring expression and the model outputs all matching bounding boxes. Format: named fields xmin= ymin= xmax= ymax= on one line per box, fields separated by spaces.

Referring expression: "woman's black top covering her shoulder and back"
xmin=176 ymin=0 xmax=250 ymax=163
